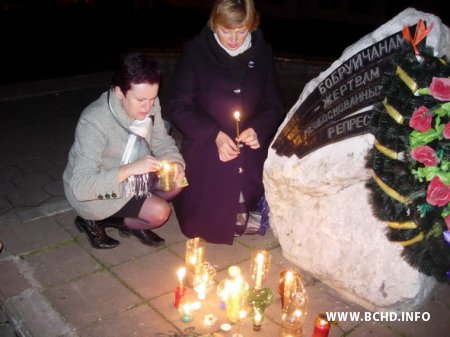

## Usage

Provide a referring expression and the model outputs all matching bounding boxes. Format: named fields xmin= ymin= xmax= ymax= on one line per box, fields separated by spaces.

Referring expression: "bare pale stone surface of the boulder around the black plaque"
xmin=264 ymin=8 xmax=450 ymax=310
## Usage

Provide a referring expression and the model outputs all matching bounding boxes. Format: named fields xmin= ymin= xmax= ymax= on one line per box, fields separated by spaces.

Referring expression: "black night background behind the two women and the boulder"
xmin=0 ymin=0 xmax=450 ymax=85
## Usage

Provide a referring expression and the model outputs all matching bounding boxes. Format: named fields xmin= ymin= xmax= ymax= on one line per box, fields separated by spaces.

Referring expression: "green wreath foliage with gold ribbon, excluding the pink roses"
xmin=367 ymin=42 xmax=450 ymax=283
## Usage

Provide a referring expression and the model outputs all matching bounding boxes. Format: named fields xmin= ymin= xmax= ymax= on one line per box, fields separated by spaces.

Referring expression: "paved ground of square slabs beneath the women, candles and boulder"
xmin=0 ymin=69 xmax=450 ymax=337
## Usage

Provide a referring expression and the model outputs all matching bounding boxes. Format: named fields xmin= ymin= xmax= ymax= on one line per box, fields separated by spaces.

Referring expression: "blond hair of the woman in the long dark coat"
xmin=208 ymin=0 xmax=259 ymax=32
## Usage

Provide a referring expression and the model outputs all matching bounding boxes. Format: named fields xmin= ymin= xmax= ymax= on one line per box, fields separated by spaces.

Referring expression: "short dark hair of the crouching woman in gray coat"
xmin=111 ymin=52 xmax=161 ymax=95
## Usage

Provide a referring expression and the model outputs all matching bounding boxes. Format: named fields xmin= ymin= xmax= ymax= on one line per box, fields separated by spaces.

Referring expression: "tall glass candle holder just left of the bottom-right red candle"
xmin=278 ymin=270 xmax=308 ymax=336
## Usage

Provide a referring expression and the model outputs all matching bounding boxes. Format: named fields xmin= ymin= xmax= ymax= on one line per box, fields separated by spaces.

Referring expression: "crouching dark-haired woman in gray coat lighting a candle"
xmin=63 ymin=53 xmax=184 ymax=248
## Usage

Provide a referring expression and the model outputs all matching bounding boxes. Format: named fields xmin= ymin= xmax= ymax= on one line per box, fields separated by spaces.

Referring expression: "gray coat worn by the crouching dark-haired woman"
xmin=63 ymin=90 xmax=184 ymax=220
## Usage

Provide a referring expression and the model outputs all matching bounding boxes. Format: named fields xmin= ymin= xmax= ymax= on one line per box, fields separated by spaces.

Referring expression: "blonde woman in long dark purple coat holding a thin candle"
xmin=168 ymin=0 xmax=283 ymax=244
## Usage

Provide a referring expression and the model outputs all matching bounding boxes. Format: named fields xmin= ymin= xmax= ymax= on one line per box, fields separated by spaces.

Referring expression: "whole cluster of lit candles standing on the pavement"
xmin=175 ymin=238 xmax=330 ymax=337
